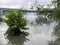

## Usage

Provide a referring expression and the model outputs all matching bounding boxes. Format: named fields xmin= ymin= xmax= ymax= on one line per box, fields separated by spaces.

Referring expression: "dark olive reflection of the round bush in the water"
xmin=5 ymin=31 xmax=28 ymax=45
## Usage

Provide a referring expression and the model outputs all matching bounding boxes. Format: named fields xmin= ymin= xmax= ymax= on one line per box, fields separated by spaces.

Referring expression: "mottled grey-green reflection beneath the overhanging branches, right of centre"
xmin=36 ymin=13 xmax=53 ymax=25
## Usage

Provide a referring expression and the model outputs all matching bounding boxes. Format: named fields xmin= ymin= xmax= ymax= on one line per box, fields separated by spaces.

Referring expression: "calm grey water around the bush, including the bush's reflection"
xmin=0 ymin=13 xmax=56 ymax=45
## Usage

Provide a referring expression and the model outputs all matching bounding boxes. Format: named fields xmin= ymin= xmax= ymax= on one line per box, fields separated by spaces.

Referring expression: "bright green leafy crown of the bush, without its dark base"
xmin=5 ymin=10 xmax=27 ymax=29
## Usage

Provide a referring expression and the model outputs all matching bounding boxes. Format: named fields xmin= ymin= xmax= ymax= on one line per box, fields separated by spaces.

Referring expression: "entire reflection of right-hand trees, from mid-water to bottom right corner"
xmin=36 ymin=13 xmax=60 ymax=45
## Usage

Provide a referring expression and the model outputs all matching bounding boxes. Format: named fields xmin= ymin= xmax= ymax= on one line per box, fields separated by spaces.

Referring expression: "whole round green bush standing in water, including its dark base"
xmin=5 ymin=10 xmax=27 ymax=34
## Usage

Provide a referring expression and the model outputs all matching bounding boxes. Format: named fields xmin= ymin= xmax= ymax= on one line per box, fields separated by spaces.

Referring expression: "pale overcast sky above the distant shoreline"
xmin=0 ymin=0 xmax=51 ymax=8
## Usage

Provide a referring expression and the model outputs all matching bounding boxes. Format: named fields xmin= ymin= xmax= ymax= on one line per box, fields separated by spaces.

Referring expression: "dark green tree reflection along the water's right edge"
xmin=49 ymin=12 xmax=60 ymax=45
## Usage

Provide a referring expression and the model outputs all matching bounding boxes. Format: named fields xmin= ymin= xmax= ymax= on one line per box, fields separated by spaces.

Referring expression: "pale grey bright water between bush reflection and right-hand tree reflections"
xmin=25 ymin=22 xmax=54 ymax=45
